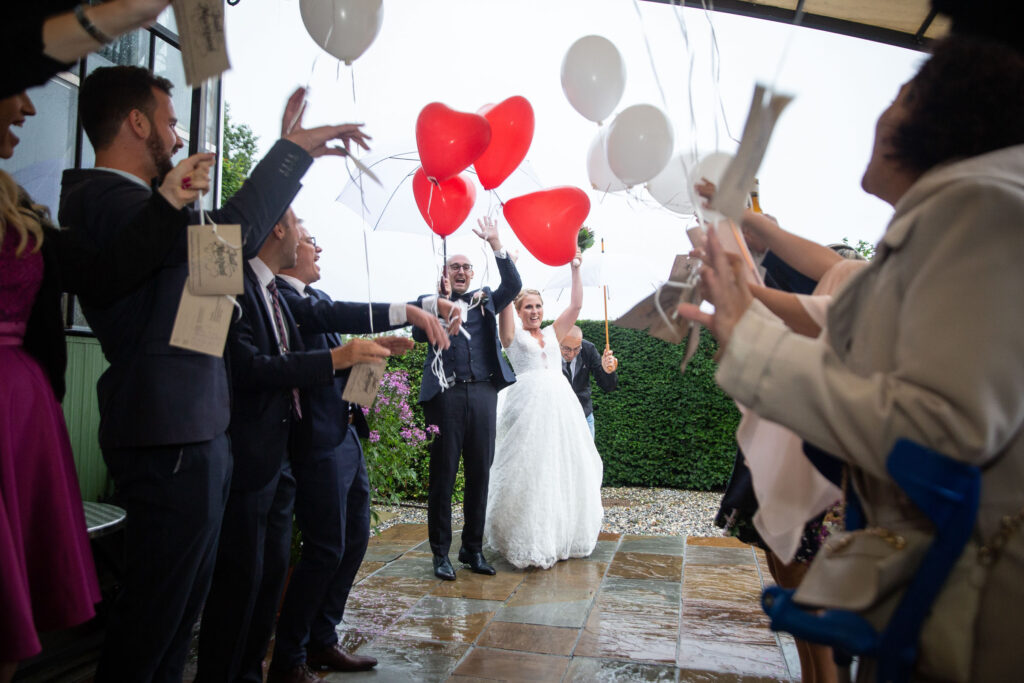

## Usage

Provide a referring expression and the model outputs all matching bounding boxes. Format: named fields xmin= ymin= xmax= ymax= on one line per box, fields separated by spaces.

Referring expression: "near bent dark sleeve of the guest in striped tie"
xmin=227 ymin=287 xmax=334 ymax=389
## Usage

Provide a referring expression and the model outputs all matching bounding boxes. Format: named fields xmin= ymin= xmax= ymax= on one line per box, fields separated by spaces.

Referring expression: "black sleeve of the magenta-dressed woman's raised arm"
xmin=55 ymin=193 xmax=187 ymax=308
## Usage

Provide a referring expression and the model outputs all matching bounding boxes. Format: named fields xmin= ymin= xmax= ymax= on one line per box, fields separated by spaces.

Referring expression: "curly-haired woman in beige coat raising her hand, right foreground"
xmin=680 ymin=37 xmax=1024 ymax=681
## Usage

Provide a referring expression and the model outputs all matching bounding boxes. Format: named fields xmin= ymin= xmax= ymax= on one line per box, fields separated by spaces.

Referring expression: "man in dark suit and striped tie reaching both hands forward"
xmin=196 ymin=209 xmax=447 ymax=683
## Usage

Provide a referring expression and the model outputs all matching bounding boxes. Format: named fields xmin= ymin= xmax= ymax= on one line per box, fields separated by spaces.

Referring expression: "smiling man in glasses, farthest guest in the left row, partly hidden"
xmin=267 ymin=223 xmax=377 ymax=683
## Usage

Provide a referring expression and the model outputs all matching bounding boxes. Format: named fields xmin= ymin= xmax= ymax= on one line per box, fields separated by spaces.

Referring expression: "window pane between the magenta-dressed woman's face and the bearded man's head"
xmin=0 ymin=78 xmax=78 ymax=214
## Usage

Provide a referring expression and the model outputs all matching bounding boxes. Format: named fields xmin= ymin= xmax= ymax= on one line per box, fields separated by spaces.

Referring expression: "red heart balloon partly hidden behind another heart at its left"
xmin=473 ymin=95 xmax=534 ymax=189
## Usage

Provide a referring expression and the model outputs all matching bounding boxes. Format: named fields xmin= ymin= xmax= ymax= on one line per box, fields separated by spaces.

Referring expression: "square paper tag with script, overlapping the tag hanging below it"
xmin=188 ymin=225 xmax=245 ymax=296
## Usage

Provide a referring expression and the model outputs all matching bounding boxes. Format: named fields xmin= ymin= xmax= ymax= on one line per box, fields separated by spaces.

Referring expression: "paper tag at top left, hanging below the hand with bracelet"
xmin=174 ymin=0 xmax=231 ymax=88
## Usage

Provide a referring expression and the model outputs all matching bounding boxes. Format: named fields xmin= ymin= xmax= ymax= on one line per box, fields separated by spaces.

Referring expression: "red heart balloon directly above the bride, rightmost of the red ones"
xmin=504 ymin=186 xmax=590 ymax=265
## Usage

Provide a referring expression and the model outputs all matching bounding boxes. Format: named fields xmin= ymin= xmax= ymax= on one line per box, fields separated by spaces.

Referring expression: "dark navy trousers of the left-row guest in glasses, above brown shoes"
xmin=273 ymin=427 xmax=370 ymax=669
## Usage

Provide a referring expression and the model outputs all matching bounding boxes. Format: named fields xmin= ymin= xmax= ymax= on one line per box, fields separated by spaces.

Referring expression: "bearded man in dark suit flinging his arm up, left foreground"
xmin=58 ymin=67 xmax=362 ymax=682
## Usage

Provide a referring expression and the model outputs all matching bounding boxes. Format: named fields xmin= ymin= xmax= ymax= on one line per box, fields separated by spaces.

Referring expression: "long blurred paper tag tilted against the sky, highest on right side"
xmin=711 ymin=84 xmax=793 ymax=223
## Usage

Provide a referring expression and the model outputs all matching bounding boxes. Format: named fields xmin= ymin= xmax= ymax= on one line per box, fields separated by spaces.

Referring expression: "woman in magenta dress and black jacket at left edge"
xmin=0 ymin=88 xmax=213 ymax=683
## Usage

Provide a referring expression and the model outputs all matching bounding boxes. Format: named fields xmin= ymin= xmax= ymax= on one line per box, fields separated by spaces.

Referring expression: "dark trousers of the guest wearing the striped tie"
xmin=196 ymin=463 xmax=295 ymax=683
